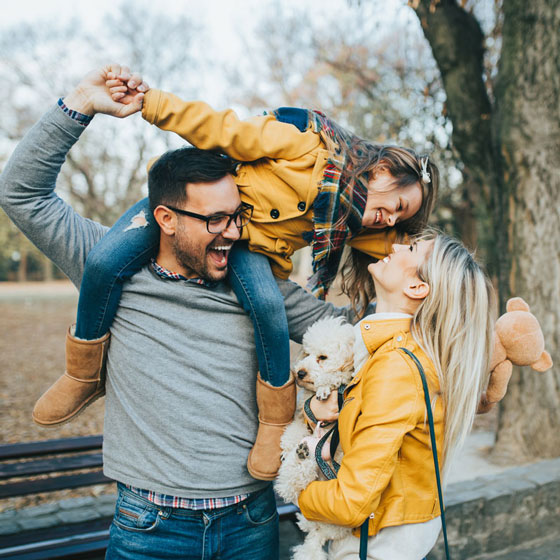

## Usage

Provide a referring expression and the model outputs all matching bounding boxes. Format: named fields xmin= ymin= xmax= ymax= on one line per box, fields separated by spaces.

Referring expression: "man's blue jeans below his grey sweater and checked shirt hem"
xmin=105 ymin=484 xmax=279 ymax=560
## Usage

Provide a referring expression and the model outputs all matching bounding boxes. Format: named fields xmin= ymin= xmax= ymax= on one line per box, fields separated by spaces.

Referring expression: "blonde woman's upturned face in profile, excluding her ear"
xmin=368 ymin=240 xmax=434 ymax=294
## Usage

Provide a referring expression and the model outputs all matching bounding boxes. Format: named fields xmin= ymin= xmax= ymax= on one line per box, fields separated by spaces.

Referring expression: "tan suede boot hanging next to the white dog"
xmin=247 ymin=374 xmax=296 ymax=480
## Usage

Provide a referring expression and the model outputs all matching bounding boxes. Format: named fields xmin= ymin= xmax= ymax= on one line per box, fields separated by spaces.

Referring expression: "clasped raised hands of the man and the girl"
xmin=64 ymin=64 xmax=148 ymax=118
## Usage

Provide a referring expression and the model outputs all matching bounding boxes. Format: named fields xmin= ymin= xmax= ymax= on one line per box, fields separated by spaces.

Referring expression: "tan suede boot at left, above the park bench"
xmin=33 ymin=327 xmax=110 ymax=426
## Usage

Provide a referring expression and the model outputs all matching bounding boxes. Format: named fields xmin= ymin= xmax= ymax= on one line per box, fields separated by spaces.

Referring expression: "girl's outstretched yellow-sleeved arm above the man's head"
xmin=142 ymin=89 xmax=321 ymax=161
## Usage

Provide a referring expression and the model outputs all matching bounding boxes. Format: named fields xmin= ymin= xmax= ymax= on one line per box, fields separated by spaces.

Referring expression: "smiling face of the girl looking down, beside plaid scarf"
xmin=362 ymin=170 xmax=422 ymax=229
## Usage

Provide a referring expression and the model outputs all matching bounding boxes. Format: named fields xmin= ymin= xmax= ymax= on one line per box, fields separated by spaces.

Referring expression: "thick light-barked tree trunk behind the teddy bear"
xmin=493 ymin=0 xmax=560 ymax=459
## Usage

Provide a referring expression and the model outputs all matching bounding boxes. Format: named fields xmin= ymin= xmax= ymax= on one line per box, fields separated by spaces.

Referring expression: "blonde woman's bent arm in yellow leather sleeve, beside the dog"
xmin=298 ymin=351 xmax=423 ymax=527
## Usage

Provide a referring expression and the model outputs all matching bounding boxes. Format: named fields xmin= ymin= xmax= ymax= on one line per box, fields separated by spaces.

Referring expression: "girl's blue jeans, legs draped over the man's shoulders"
xmin=76 ymin=199 xmax=290 ymax=387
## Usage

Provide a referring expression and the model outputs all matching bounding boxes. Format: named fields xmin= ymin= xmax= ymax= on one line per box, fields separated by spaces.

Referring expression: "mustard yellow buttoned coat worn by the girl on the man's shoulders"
xmin=142 ymin=89 xmax=395 ymax=278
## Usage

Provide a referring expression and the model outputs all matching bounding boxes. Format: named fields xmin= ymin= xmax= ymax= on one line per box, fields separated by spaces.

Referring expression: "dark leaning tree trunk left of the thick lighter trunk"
xmin=410 ymin=0 xmax=501 ymax=275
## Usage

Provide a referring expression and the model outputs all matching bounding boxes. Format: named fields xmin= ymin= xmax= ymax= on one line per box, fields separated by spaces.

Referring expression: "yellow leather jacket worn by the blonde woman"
xmin=298 ymin=319 xmax=443 ymax=535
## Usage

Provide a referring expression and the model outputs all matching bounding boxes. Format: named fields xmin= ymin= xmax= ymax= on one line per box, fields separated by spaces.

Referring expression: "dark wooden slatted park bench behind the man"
xmin=0 ymin=436 xmax=297 ymax=560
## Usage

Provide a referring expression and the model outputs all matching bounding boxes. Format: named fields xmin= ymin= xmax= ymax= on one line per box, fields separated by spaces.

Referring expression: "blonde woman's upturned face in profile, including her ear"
xmin=368 ymin=240 xmax=434 ymax=305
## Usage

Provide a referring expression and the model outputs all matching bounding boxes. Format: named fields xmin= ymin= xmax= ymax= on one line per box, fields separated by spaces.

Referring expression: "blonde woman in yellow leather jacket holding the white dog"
xmin=298 ymin=235 xmax=494 ymax=560
